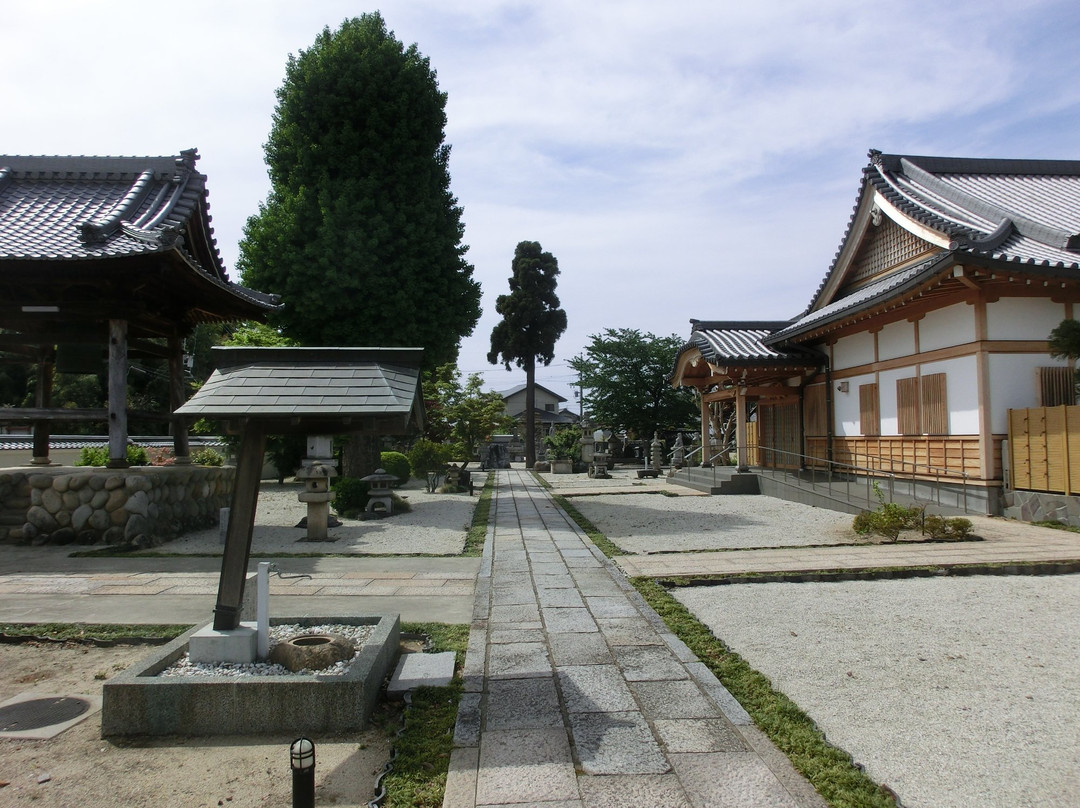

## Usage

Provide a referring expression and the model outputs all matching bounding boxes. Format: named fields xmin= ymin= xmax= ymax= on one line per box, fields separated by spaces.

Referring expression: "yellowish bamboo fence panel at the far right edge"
xmin=1009 ymin=406 xmax=1080 ymax=495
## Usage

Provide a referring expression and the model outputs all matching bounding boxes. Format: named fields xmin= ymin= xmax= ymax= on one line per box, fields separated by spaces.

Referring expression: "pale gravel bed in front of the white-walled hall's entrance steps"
xmin=572 ymin=494 xmax=862 ymax=554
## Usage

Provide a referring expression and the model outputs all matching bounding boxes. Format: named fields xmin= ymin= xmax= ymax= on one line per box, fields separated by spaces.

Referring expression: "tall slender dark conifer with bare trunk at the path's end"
xmin=487 ymin=241 xmax=566 ymax=469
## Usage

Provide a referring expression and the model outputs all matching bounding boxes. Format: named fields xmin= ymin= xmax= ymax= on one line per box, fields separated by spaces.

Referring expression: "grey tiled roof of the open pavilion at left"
xmin=0 ymin=149 xmax=273 ymax=308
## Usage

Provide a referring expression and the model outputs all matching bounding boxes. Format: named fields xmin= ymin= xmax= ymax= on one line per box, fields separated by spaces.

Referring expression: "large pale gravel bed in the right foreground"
xmin=673 ymin=575 xmax=1080 ymax=808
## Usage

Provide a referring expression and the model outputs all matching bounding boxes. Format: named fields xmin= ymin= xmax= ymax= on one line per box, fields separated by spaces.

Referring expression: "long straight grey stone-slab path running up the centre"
xmin=443 ymin=471 xmax=824 ymax=808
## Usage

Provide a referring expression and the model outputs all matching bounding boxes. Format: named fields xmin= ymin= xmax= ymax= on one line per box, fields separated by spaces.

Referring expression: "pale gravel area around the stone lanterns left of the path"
xmin=140 ymin=472 xmax=484 ymax=555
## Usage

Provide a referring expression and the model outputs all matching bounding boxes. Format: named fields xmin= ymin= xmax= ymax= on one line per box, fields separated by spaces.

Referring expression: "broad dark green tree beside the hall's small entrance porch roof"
xmin=570 ymin=328 xmax=698 ymax=440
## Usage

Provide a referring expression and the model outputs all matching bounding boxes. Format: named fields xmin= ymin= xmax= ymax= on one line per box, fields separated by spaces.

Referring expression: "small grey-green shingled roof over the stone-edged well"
xmin=176 ymin=348 xmax=423 ymax=434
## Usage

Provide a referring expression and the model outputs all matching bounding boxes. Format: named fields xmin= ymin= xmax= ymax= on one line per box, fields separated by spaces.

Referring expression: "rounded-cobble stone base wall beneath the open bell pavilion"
xmin=0 ymin=466 xmax=235 ymax=547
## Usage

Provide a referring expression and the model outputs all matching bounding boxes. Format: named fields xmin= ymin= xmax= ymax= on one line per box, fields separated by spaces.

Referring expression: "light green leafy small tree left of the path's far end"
xmin=428 ymin=365 xmax=516 ymax=464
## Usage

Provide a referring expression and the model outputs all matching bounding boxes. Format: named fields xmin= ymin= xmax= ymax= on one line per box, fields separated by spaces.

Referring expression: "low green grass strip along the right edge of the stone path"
xmin=555 ymin=496 xmax=896 ymax=808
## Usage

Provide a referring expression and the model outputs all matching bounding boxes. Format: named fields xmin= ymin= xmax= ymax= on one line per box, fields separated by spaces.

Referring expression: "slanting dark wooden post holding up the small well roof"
xmin=214 ymin=421 xmax=267 ymax=631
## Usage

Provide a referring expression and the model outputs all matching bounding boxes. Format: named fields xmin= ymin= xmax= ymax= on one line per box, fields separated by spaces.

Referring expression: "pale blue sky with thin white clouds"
xmin=0 ymin=0 xmax=1080 ymax=409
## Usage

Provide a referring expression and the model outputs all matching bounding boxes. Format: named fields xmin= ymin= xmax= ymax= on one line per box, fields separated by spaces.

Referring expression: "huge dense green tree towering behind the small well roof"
xmin=245 ymin=12 xmax=480 ymax=367
